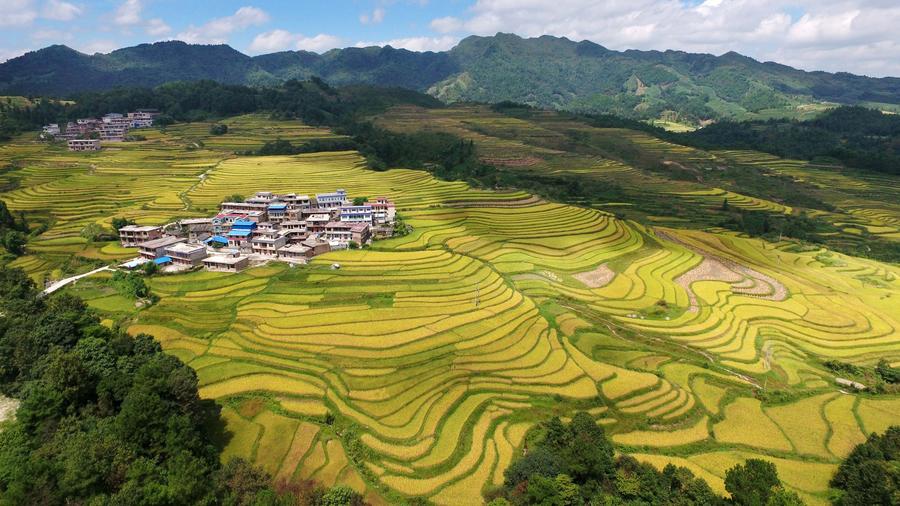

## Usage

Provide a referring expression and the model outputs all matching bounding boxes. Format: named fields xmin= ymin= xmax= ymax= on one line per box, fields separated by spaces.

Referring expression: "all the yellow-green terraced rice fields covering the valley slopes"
xmin=0 ymin=110 xmax=900 ymax=504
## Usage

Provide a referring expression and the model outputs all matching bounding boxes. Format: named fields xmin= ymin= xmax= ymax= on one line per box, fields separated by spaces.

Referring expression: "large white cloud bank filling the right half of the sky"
xmin=426 ymin=0 xmax=900 ymax=76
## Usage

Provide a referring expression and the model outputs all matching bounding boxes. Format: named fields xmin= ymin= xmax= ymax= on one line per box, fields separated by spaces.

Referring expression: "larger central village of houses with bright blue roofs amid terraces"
xmin=119 ymin=190 xmax=396 ymax=272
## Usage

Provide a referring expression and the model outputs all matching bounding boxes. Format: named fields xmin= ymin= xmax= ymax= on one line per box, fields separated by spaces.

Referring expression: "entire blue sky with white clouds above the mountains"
xmin=0 ymin=0 xmax=900 ymax=76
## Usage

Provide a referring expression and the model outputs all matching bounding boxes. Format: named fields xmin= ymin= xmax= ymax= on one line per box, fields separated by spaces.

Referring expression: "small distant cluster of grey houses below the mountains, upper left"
xmin=41 ymin=109 xmax=159 ymax=151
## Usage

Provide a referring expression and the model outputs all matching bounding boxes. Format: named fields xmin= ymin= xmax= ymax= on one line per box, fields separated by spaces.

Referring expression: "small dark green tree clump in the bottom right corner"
xmin=831 ymin=426 xmax=900 ymax=506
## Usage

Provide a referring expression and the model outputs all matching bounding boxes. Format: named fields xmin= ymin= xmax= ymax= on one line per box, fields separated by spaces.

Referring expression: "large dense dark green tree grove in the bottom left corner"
xmin=0 ymin=268 xmax=362 ymax=506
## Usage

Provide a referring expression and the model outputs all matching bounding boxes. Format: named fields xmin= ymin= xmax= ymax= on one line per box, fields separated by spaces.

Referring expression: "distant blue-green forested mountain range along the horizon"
xmin=0 ymin=33 xmax=900 ymax=123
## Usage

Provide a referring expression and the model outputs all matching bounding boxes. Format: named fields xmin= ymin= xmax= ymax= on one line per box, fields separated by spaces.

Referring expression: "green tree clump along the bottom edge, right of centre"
xmin=489 ymin=413 xmax=802 ymax=506
